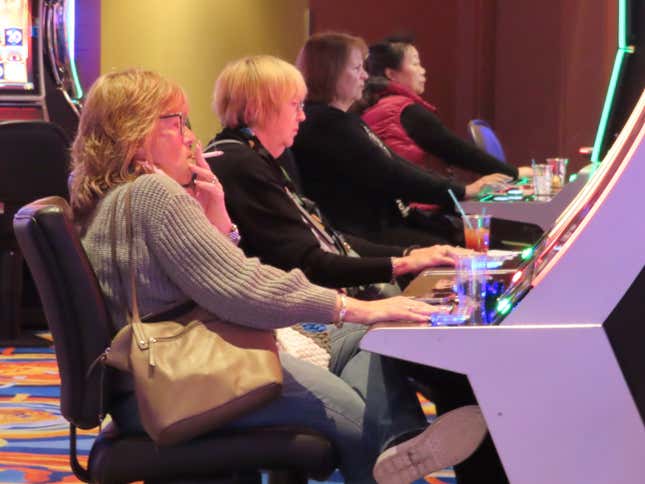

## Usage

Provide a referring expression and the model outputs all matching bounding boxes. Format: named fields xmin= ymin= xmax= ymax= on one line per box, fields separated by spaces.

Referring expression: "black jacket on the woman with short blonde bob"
xmin=208 ymin=129 xmax=403 ymax=288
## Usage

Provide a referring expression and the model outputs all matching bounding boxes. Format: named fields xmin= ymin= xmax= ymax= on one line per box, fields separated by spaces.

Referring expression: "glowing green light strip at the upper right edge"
xmin=591 ymin=0 xmax=634 ymax=163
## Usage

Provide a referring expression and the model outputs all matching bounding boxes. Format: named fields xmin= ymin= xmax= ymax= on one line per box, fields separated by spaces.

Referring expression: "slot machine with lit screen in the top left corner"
xmin=0 ymin=0 xmax=83 ymax=138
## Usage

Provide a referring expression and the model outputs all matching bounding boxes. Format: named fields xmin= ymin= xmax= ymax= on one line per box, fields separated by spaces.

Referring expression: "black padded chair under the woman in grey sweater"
xmin=14 ymin=197 xmax=335 ymax=484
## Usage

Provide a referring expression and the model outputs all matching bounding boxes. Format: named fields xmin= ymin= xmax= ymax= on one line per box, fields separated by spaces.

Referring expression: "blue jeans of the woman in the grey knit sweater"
xmin=110 ymin=324 xmax=427 ymax=484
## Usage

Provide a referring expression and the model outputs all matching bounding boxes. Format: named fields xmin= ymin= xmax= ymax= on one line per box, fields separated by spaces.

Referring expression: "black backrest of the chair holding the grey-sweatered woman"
xmin=13 ymin=197 xmax=113 ymax=429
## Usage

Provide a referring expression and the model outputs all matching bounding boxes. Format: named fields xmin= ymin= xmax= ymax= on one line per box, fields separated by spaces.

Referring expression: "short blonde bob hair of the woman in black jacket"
xmin=213 ymin=55 xmax=307 ymax=128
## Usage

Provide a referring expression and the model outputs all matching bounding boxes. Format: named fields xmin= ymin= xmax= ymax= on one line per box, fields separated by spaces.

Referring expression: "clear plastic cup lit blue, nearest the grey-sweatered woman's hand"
xmin=455 ymin=254 xmax=487 ymax=324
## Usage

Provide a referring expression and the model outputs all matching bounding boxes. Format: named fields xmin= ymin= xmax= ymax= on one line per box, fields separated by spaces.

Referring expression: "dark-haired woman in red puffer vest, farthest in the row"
xmin=357 ymin=37 xmax=531 ymax=178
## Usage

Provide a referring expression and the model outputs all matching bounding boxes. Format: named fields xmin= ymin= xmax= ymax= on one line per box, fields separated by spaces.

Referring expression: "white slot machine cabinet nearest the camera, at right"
xmin=361 ymin=91 xmax=645 ymax=484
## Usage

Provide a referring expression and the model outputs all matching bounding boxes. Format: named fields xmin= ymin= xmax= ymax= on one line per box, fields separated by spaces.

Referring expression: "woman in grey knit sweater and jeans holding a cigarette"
xmin=71 ymin=69 xmax=484 ymax=483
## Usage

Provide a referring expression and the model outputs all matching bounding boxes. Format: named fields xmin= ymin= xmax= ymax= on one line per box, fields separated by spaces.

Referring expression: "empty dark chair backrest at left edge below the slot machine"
xmin=0 ymin=120 xmax=70 ymax=237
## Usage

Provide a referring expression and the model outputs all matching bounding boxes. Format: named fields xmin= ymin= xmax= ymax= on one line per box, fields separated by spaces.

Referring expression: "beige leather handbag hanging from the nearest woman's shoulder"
xmin=105 ymin=187 xmax=282 ymax=445
